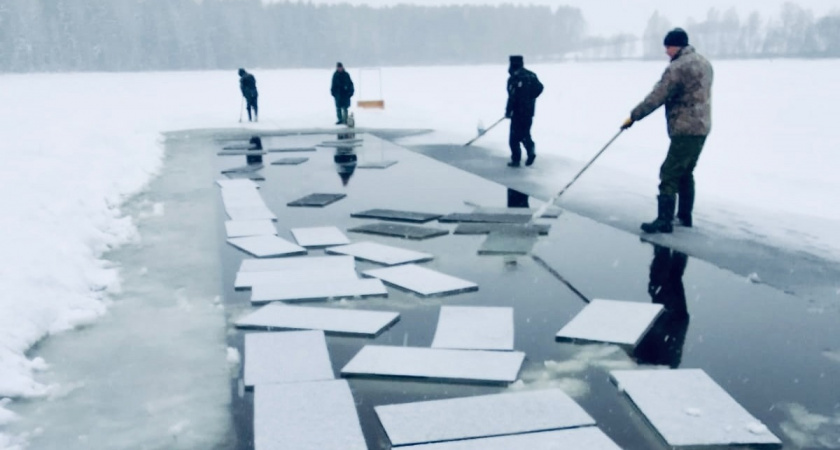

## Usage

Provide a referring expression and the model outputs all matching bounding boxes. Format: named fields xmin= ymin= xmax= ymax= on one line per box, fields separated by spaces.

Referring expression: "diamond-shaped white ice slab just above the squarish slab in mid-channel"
xmin=362 ymin=264 xmax=478 ymax=296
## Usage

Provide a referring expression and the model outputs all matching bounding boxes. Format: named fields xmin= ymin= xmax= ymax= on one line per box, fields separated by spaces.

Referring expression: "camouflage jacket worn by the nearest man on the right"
xmin=630 ymin=46 xmax=714 ymax=137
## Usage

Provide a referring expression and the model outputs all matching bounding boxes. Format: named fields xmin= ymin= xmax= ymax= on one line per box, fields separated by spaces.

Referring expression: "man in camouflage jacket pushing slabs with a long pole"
xmin=621 ymin=28 xmax=714 ymax=233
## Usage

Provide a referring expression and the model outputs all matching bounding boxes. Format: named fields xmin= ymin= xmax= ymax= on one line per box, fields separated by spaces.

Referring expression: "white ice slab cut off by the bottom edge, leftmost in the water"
xmin=254 ymin=380 xmax=367 ymax=450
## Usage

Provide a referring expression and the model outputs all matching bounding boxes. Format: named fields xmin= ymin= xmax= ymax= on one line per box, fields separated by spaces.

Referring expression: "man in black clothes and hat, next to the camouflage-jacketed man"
xmin=505 ymin=55 xmax=543 ymax=167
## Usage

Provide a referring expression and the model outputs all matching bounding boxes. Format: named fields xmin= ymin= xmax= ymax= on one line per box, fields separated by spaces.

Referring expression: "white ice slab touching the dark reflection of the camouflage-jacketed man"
xmin=557 ymin=299 xmax=663 ymax=346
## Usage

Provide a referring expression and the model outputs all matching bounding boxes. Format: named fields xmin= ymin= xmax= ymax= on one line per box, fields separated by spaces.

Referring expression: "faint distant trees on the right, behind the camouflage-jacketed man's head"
xmin=578 ymin=3 xmax=840 ymax=59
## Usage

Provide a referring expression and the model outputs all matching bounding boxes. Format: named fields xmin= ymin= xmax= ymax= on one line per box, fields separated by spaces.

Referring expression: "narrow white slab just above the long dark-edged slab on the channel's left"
xmin=251 ymin=279 xmax=388 ymax=303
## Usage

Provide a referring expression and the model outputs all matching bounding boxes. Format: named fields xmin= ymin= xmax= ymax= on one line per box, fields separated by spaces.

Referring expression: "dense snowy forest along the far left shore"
xmin=0 ymin=0 xmax=586 ymax=72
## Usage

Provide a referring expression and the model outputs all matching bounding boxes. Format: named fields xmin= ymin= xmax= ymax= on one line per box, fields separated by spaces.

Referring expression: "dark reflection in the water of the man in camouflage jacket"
xmin=633 ymin=244 xmax=689 ymax=369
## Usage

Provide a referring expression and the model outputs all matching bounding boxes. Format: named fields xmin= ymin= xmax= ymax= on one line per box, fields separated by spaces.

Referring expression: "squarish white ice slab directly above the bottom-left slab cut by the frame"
xmin=244 ymin=331 xmax=335 ymax=386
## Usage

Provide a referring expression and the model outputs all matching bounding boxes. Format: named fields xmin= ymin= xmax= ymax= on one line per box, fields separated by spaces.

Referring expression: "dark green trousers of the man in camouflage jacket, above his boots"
xmin=659 ymin=136 xmax=706 ymax=196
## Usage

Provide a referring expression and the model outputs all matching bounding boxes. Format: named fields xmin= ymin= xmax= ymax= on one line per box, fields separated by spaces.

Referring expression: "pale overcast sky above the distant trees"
xmin=282 ymin=0 xmax=840 ymax=35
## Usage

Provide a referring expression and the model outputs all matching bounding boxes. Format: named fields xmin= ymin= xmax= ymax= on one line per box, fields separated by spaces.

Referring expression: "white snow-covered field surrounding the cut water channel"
xmin=0 ymin=60 xmax=840 ymax=448
